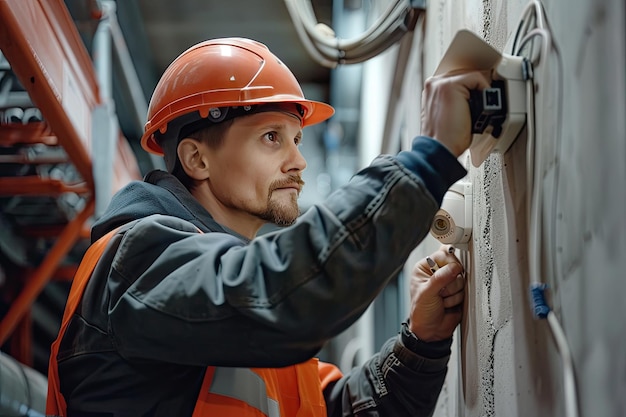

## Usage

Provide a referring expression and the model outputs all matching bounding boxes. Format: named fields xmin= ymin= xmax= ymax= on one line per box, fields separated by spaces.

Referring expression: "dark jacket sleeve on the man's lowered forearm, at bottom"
xmin=324 ymin=323 xmax=452 ymax=417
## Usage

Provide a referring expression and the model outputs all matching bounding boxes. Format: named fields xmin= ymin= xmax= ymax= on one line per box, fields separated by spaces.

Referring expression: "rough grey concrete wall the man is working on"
xmin=392 ymin=0 xmax=626 ymax=417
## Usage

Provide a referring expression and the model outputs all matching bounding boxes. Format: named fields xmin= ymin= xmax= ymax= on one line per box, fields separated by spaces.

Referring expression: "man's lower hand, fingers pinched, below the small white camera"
xmin=409 ymin=245 xmax=465 ymax=342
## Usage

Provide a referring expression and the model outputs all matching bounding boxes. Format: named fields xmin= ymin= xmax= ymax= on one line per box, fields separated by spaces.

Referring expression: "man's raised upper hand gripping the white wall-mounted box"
xmin=421 ymin=71 xmax=491 ymax=157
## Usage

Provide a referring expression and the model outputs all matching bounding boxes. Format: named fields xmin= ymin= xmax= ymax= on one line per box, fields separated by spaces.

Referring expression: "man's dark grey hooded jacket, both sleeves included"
xmin=58 ymin=138 xmax=466 ymax=417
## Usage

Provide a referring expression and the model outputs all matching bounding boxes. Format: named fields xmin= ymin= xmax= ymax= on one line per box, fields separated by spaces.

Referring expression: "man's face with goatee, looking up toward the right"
xmin=207 ymin=111 xmax=306 ymax=226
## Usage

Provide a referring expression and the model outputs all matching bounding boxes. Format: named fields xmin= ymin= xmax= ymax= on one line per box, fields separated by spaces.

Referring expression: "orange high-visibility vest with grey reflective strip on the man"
xmin=46 ymin=229 xmax=342 ymax=417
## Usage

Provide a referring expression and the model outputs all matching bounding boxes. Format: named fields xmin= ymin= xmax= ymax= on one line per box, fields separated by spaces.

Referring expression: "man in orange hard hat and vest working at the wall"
xmin=48 ymin=38 xmax=489 ymax=417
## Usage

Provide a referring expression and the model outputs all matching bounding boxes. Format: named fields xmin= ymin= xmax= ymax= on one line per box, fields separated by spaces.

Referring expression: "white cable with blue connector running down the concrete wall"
xmin=513 ymin=0 xmax=578 ymax=417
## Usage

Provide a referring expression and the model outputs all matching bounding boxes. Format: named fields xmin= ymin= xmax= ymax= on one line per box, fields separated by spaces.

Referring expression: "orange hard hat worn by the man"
xmin=141 ymin=38 xmax=335 ymax=155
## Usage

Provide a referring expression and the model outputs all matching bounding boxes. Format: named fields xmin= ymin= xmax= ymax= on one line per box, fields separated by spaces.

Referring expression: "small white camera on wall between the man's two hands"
xmin=430 ymin=181 xmax=472 ymax=249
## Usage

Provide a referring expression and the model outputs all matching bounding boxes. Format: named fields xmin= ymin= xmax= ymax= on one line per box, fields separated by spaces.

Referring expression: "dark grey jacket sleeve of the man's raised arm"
xmin=107 ymin=138 xmax=462 ymax=367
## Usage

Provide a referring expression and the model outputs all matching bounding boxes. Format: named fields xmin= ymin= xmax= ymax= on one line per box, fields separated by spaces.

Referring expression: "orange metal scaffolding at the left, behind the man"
xmin=0 ymin=0 xmax=138 ymax=364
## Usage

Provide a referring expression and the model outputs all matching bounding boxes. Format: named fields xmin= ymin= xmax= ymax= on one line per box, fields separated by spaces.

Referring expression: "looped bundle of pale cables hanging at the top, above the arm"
xmin=285 ymin=0 xmax=419 ymax=68
